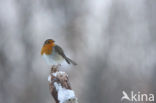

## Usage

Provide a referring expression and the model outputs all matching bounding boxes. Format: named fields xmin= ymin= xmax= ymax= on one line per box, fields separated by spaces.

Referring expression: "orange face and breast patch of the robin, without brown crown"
xmin=41 ymin=43 xmax=55 ymax=55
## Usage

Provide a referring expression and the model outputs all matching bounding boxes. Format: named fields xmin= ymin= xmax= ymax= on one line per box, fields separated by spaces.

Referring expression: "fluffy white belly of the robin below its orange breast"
xmin=43 ymin=52 xmax=64 ymax=65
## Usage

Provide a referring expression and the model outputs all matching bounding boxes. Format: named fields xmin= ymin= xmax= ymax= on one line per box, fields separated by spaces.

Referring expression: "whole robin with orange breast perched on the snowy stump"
xmin=41 ymin=39 xmax=77 ymax=65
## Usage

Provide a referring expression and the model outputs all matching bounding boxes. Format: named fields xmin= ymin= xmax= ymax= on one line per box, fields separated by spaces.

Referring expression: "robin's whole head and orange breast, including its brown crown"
xmin=41 ymin=39 xmax=55 ymax=55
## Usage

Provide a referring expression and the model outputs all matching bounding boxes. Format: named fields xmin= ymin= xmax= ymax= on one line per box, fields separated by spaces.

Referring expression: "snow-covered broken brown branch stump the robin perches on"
xmin=48 ymin=66 xmax=78 ymax=103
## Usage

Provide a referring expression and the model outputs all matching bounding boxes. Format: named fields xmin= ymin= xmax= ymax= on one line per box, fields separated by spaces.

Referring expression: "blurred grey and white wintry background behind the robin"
xmin=0 ymin=0 xmax=156 ymax=103
